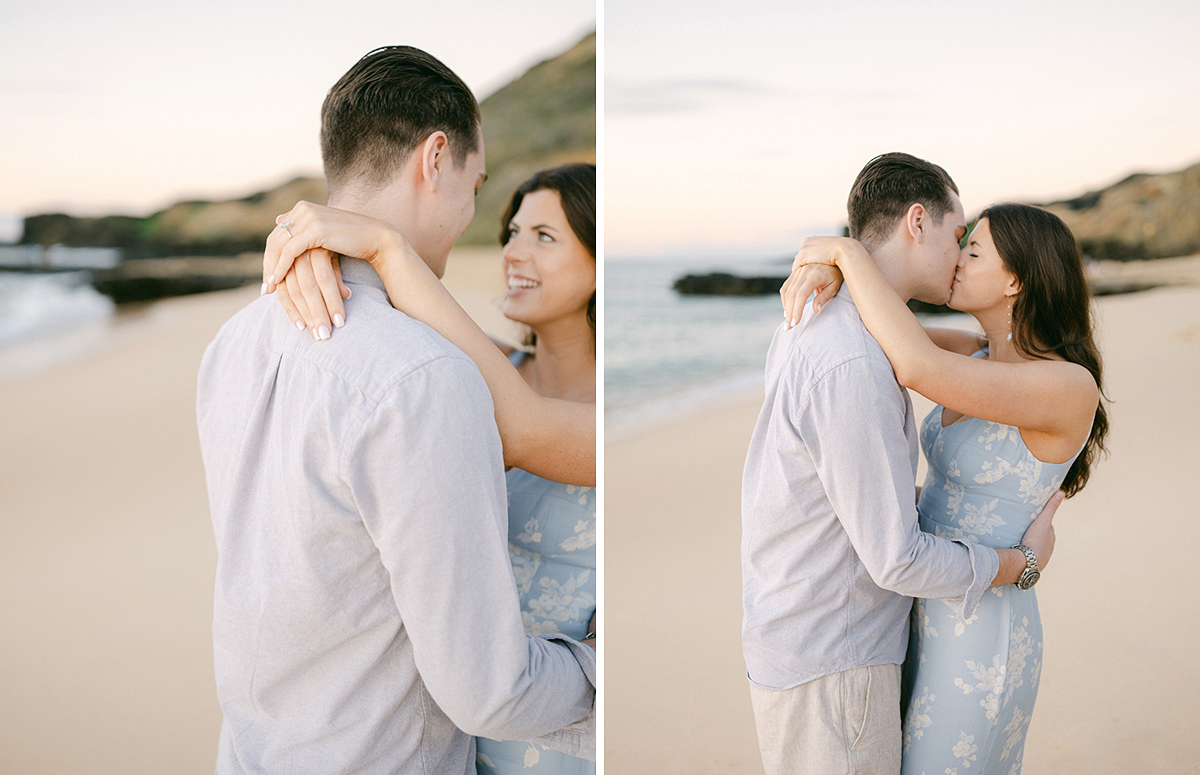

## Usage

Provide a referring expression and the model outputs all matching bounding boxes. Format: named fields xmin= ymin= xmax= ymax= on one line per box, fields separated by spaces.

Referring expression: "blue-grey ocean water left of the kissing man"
xmin=604 ymin=257 xmax=791 ymax=433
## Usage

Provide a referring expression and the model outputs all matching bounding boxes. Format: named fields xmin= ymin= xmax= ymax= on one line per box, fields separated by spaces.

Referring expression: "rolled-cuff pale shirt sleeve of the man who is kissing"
xmin=798 ymin=358 xmax=1000 ymax=617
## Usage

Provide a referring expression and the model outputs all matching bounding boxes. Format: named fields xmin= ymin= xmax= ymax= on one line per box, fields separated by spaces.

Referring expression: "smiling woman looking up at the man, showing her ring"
xmin=264 ymin=164 xmax=596 ymax=775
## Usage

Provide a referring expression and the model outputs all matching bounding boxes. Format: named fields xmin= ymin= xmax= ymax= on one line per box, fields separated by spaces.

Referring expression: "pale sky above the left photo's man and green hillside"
xmin=0 ymin=0 xmax=596 ymax=233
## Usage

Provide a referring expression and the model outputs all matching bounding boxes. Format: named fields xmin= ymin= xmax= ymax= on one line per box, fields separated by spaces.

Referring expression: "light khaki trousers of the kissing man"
xmin=750 ymin=665 xmax=900 ymax=775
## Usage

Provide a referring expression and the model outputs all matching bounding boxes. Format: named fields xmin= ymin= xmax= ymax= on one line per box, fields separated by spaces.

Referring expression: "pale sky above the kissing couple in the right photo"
xmin=604 ymin=0 xmax=1200 ymax=258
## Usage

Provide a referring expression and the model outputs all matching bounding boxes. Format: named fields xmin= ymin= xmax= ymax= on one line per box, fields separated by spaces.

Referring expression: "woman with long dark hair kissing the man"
xmin=782 ymin=204 xmax=1108 ymax=775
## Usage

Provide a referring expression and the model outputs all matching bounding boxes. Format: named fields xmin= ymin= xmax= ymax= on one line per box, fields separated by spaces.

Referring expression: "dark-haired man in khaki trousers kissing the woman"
xmin=742 ymin=154 xmax=1058 ymax=775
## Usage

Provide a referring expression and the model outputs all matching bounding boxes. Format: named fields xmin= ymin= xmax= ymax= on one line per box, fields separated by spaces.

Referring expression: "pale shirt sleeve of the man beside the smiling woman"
xmin=343 ymin=356 xmax=594 ymax=739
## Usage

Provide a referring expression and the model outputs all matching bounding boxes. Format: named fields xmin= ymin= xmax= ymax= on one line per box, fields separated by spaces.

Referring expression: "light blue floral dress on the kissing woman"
xmin=901 ymin=353 xmax=1082 ymax=775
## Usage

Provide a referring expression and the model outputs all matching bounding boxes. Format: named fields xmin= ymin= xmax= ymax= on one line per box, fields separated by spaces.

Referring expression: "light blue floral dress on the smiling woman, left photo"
xmin=475 ymin=353 xmax=596 ymax=775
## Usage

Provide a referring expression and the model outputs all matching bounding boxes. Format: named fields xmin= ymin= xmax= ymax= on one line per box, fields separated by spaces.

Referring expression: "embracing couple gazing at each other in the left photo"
xmin=197 ymin=47 xmax=596 ymax=775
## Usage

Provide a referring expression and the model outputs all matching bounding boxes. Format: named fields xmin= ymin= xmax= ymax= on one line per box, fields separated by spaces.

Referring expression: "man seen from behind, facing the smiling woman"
xmin=197 ymin=47 xmax=595 ymax=775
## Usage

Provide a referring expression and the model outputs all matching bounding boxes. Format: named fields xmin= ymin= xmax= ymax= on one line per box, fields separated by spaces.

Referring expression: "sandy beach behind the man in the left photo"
xmin=0 ymin=248 xmax=514 ymax=775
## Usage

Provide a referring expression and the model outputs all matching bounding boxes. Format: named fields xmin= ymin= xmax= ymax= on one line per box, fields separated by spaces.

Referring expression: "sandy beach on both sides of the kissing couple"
xmin=604 ymin=287 xmax=1200 ymax=775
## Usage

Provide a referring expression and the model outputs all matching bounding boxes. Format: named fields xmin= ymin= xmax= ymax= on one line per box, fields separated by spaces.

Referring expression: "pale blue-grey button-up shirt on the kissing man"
xmin=742 ymin=287 xmax=1000 ymax=689
